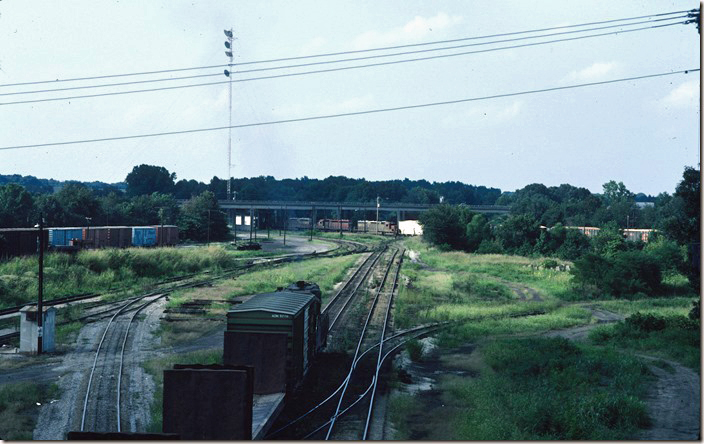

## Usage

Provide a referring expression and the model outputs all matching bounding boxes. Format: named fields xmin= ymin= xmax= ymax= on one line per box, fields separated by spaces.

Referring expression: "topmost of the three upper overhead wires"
xmin=0 ymin=9 xmax=698 ymax=87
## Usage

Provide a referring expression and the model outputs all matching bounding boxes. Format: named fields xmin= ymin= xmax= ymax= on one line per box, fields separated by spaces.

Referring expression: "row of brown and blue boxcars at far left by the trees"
xmin=0 ymin=225 xmax=179 ymax=258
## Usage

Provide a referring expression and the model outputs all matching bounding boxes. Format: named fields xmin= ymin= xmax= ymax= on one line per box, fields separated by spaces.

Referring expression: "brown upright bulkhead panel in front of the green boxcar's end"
xmin=223 ymin=331 xmax=288 ymax=394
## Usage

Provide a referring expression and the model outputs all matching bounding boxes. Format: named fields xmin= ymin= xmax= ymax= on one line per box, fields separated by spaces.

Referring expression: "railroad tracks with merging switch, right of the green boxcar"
xmin=266 ymin=248 xmax=442 ymax=440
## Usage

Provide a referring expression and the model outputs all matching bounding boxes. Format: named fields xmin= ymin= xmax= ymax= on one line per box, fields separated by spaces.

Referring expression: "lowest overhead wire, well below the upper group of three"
xmin=0 ymin=68 xmax=700 ymax=150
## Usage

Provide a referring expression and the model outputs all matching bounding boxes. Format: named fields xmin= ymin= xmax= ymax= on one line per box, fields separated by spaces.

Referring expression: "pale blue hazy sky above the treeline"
xmin=0 ymin=0 xmax=701 ymax=195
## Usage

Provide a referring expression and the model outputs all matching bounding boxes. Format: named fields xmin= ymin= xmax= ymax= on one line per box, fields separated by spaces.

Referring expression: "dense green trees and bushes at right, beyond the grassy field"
xmin=420 ymin=167 xmax=701 ymax=297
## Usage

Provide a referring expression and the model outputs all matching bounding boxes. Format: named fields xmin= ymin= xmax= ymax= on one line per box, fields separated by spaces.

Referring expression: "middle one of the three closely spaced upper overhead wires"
xmin=0 ymin=14 xmax=689 ymax=96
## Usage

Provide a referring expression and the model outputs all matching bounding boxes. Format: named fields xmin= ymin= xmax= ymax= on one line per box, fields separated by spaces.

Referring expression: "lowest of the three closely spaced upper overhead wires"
xmin=0 ymin=22 xmax=692 ymax=106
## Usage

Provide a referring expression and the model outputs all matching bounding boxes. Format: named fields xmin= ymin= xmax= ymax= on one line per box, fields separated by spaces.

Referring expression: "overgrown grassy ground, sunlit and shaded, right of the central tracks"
xmin=391 ymin=239 xmax=699 ymax=440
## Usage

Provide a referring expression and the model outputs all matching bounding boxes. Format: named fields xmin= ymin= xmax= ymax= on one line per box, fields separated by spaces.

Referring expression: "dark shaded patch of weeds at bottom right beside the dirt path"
xmin=452 ymin=338 xmax=649 ymax=440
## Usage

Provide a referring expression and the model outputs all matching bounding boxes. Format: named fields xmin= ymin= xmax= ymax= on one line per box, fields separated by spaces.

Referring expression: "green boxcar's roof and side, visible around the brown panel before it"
xmin=227 ymin=291 xmax=320 ymax=388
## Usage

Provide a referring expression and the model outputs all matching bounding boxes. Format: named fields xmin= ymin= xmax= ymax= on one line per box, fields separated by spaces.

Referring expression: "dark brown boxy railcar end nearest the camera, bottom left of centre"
xmin=163 ymin=365 xmax=254 ymax=440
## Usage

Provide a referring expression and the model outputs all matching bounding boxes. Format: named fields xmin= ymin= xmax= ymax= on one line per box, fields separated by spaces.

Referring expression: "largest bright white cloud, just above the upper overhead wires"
xmin=353 ymin=12 xmax=462 ymax=49
